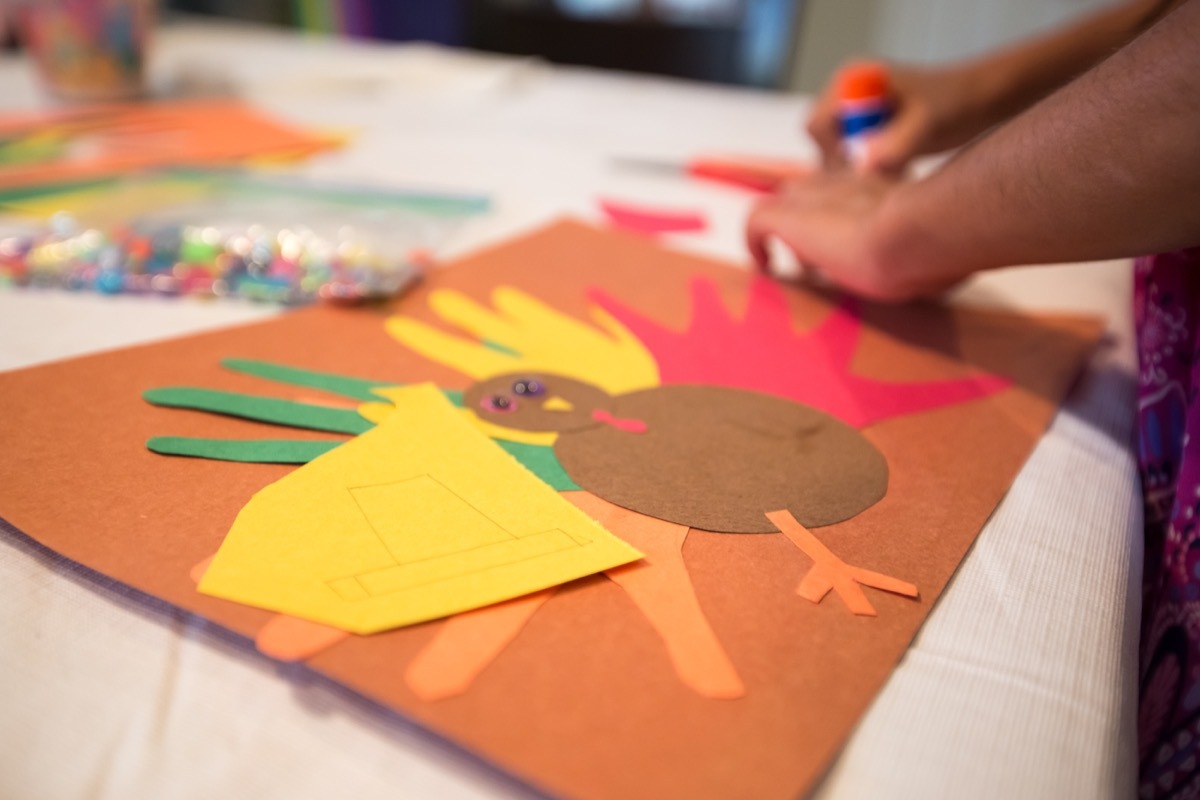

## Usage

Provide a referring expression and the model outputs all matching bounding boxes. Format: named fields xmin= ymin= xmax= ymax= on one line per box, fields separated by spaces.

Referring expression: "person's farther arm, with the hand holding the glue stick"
xmin=808 ymin=0 xmax=1178 ymax=173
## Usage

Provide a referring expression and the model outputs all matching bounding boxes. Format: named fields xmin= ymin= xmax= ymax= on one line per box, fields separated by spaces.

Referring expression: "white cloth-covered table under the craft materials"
xmin=0 ymin=22 xmax=1141 ymax=800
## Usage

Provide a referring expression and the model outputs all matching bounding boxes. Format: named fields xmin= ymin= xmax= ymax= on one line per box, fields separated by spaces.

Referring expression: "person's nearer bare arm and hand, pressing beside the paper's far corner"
xmin=746 ymin=0 xmax=1200 ymax=300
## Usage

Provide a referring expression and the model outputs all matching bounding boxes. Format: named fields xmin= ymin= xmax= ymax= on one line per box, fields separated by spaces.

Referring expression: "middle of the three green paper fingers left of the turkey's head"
xmin=142 ymin=386 xmax=374 ymax=435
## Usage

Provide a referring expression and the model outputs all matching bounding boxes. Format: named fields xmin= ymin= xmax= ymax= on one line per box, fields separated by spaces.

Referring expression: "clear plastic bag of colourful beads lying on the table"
xmin=0 ymin=172 xmax=488 ymax=305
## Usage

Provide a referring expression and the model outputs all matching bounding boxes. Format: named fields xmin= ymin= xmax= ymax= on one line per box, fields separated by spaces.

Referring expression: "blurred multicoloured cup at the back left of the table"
xmin=20 ymin=0 xmax=155 ymax=102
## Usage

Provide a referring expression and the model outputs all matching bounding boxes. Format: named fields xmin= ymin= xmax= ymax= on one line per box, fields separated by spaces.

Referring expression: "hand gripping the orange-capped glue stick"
xmin=808 ymin=64 xmax=988 ymax=175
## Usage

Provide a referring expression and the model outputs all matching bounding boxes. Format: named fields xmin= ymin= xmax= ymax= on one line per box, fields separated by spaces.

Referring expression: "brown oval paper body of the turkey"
xmin=547 ymin=378 xmax=888 ymax=534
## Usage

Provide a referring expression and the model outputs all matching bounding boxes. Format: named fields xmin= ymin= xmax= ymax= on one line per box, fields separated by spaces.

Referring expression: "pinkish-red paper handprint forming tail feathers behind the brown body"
xmin=588 ymin=278 xmax=1009 ymax=428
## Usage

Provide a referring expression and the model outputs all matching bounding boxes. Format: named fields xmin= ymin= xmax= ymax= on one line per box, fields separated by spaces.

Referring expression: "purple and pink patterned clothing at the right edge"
xmin=1134 ymin=248 xmax=1200 ymax=800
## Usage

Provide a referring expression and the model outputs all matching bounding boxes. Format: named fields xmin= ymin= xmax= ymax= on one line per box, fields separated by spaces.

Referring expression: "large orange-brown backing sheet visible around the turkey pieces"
xmin=0 ymin=222 xmax=1100 ymax=798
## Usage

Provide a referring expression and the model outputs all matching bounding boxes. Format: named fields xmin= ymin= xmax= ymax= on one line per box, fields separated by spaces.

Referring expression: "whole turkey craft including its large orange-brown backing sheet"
xmin=0 ymin=222 xmax=1100 ymax=798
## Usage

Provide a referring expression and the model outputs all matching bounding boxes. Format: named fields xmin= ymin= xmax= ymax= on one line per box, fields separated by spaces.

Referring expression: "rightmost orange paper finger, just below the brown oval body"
xmin=564 ymin=492 xmax=745 ymax=698
